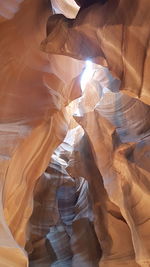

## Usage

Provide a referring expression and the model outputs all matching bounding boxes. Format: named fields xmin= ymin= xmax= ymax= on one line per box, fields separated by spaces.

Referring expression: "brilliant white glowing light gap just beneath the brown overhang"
xmin=80 ymin=60 xmax=94 ymax=92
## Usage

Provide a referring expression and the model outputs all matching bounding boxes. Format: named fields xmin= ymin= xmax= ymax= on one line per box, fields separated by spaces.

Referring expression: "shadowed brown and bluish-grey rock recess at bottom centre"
xmin=28 ymin=148 xmax=100 ymax=267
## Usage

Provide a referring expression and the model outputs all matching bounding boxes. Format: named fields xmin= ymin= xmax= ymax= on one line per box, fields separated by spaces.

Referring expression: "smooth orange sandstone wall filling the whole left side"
xmin=0 ymin=0 xmax=82 ymax=267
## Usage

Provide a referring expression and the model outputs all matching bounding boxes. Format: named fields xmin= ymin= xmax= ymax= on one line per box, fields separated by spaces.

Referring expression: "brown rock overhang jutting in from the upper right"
xmin=41 ymin=0 xmax=150 ymax=104
